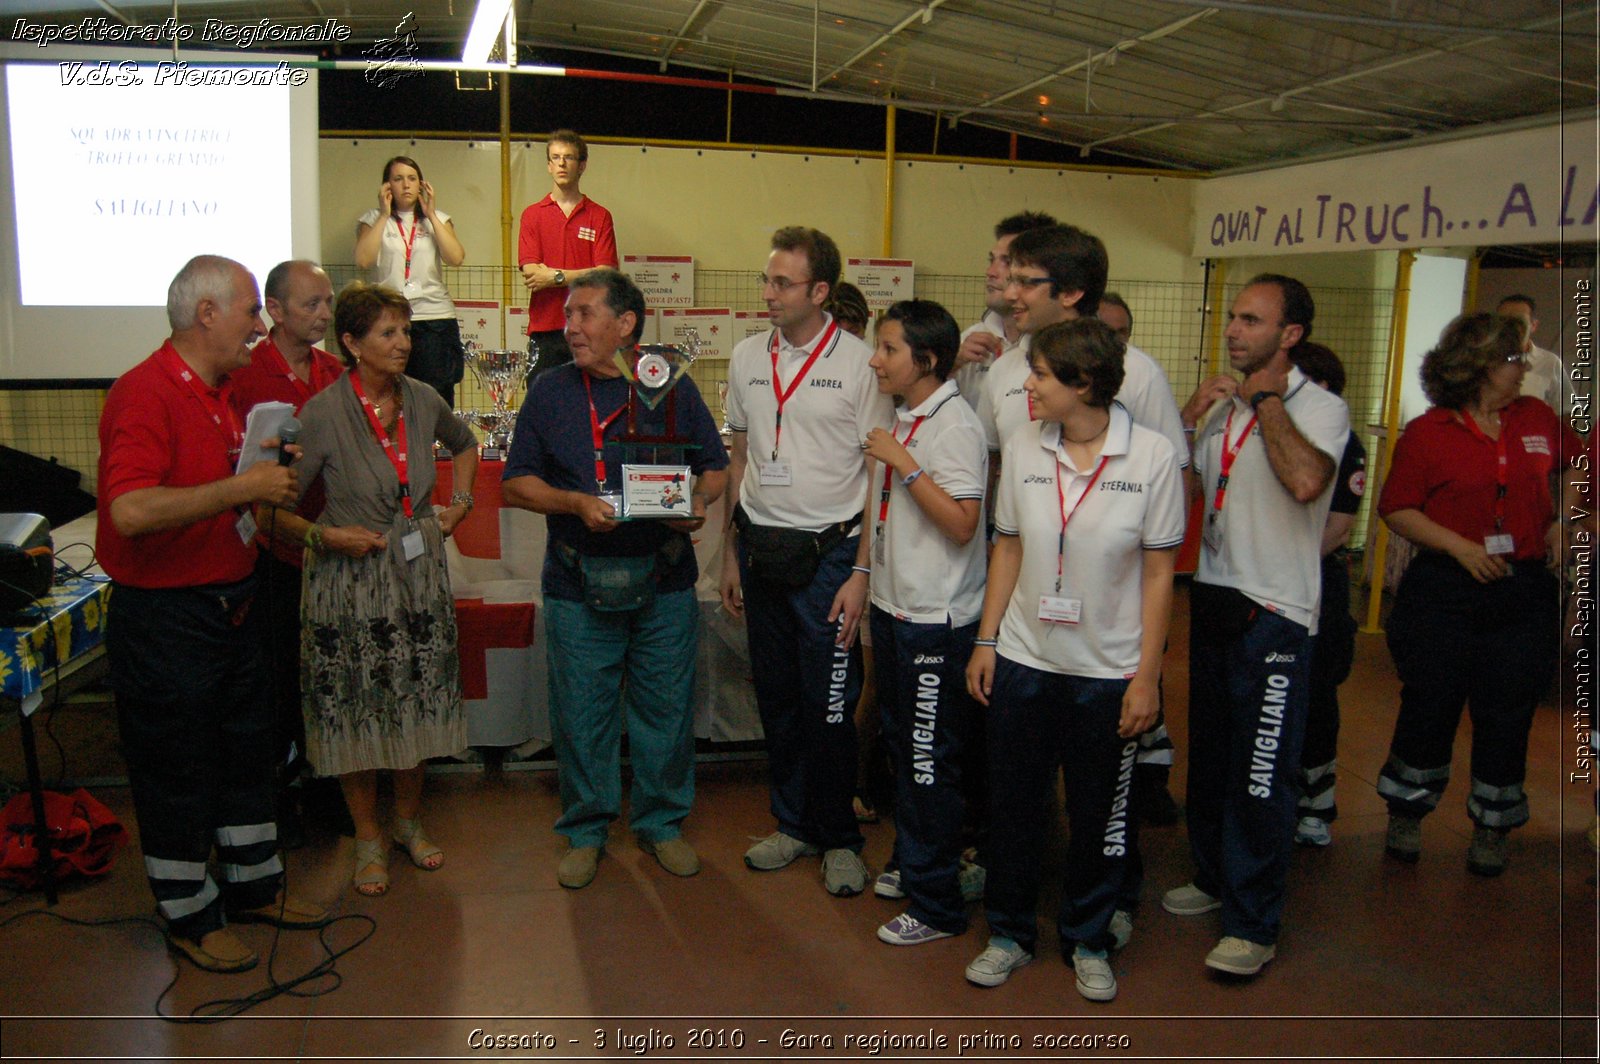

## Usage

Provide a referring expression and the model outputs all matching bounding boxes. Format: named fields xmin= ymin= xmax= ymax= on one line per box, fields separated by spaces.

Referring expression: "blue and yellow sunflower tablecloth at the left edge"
xmin=0 ymin=576 xmax=110 ymax=712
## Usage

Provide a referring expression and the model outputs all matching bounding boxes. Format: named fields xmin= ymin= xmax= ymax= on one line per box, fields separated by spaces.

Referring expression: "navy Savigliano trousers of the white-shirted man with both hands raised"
xmin=1189 ymin=581 xmax=1310 ymax=946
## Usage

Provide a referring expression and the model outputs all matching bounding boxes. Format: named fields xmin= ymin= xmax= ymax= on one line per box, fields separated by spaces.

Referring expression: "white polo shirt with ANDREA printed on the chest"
xmin=726 ymin=314 xmax=894 ymax=531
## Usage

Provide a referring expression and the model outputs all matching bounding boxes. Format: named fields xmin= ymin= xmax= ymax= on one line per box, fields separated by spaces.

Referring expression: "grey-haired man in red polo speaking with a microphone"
xmin=98 ymin=254 xmax=328 ymax=971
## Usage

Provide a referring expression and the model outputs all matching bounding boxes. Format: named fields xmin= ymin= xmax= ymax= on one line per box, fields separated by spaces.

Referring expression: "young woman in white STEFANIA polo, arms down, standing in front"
xmin=966 ymin=318 xmax=1184 ymax=1002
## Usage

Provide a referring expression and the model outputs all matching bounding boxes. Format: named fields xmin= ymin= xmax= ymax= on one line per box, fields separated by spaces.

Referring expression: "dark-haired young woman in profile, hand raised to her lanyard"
xmin=866 ymin=299 xmax=989 ymax=946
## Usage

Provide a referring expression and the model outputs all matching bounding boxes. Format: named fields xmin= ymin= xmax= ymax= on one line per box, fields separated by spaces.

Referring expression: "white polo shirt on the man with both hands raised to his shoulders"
xmin=1195 ymin=368 xmax=1350 ymax=634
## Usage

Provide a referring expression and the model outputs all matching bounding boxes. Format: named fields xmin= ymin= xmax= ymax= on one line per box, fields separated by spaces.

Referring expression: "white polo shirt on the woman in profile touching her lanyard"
xmin=869 ymin=381 xmax=989 ymax=627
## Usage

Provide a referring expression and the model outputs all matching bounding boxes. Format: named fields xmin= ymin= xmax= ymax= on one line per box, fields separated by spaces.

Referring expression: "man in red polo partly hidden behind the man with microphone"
xmin=229 ymin=259 xmax=354 ymax=850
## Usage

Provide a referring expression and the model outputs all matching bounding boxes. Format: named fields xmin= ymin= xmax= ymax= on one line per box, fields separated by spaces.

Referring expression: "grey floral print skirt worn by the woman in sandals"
xmin=301 ymin=517 xmax=467 ymax=776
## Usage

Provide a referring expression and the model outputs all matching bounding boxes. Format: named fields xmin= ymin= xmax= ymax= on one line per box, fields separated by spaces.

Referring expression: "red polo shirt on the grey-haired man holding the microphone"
xmin=96 ymin=341 xmax=256 ymax=587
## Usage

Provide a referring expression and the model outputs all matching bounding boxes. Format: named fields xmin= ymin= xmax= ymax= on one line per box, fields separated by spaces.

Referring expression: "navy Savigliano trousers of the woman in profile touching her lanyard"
xmin=870 ymin=606 xmax=978 ymax=934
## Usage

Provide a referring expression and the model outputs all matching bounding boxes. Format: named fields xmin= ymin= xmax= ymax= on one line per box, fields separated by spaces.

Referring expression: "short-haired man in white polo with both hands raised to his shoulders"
xmin=1162 ymin=274 xmax=1350 ymax=976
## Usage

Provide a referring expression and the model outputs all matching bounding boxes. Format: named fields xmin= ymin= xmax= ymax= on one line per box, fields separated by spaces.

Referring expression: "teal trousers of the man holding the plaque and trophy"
xmin=544 ymin=589 xmax=699 ymax=846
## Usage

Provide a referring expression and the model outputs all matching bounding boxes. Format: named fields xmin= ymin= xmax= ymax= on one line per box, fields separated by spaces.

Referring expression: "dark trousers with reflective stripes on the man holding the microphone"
xmin=106 ymin=579 xmax=283 ymax=939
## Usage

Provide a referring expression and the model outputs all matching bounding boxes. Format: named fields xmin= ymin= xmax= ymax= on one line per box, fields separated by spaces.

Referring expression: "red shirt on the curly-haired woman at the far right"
xmin=1378 ymin=397 xmax=1584 ymax=560
